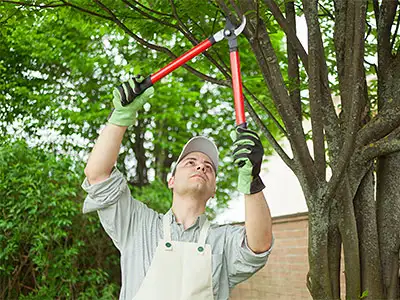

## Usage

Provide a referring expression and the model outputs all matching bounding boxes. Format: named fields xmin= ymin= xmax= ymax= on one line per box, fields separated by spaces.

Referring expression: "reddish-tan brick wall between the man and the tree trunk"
xmin=230 ymin=213 xmax=344 ymax=300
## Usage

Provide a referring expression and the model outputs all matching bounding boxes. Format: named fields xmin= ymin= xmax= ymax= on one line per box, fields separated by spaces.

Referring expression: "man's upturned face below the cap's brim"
xmin=168 ymin=152 xmax=216 ymax=201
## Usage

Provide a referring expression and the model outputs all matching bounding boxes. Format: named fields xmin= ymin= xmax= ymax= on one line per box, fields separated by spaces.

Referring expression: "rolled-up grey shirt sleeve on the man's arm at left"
xmin=82 ymin=169 xmax=157 ymax=251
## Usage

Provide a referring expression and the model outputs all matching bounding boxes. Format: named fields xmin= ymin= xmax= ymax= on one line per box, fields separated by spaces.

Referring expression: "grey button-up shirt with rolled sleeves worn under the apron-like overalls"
xmin=82 ymin=169 xmax=271 ymax=300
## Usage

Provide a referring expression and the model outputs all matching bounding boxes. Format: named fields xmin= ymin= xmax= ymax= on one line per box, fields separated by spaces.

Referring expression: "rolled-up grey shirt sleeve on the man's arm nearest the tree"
xmin=224 ymin=225 xmax=273 ymax=289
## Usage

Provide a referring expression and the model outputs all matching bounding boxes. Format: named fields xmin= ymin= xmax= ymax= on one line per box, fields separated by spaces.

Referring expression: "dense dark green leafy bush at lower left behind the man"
xmin=0 ymin=140 xmax=119 ymax=299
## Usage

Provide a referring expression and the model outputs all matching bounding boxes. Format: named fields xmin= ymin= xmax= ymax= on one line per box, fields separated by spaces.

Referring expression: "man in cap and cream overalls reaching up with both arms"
xmin=82 ymin=78 xmax=272 ymax=300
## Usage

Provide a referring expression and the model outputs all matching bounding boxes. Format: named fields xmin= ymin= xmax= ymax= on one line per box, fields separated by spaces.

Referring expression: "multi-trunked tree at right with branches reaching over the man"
xmin=2 ymin=0 xmax=400 ymax=299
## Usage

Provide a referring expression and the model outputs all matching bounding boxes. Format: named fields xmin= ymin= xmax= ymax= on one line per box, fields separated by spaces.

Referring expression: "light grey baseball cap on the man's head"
xmin=172 ymin=136 xmax=219 ymax=175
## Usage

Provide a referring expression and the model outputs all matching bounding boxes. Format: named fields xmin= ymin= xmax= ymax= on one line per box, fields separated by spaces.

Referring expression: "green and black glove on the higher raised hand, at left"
xmin=108 ymin=75 xmax=154 ymax=126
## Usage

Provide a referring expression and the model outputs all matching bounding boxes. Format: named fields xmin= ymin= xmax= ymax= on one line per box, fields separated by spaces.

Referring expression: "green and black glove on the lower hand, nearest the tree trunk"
xmin=231 ymin=127 xmax=265 ymax=194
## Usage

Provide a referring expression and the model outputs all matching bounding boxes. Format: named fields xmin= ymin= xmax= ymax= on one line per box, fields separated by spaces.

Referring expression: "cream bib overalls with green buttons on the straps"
xmin=133 ymin=215 xmax=214 ymax=300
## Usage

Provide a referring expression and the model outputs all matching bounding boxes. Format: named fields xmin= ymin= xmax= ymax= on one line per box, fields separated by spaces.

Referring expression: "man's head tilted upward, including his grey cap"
xmin=168 ymin=137 xmax=218 ymax=205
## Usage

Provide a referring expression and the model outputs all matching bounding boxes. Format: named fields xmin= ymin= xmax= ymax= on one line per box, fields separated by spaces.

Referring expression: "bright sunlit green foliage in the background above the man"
xmin=0 ymin=1 xmax=282 ymax=213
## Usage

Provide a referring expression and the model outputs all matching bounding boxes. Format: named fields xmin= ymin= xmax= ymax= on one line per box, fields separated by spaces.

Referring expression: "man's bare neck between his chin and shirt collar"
xmin=172 ymin=197 xmax=205 ymax=229
